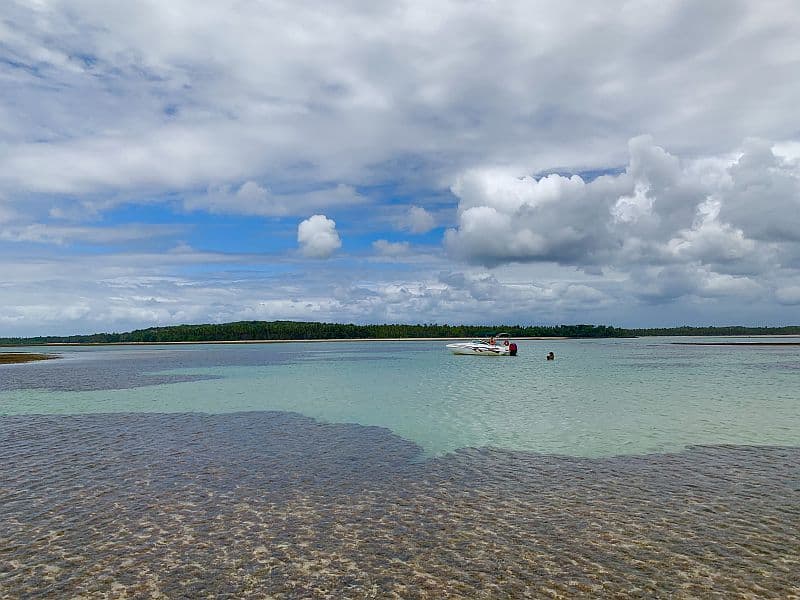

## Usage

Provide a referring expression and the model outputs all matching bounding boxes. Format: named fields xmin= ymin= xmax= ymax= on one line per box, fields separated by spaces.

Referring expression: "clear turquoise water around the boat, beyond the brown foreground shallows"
xmin=0 ymin=338 xmax=800 ymax=457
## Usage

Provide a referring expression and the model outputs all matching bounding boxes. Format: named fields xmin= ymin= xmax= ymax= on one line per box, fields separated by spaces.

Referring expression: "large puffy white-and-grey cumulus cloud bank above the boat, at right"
xmin=445 ymin=136 xmax=800 ymax=304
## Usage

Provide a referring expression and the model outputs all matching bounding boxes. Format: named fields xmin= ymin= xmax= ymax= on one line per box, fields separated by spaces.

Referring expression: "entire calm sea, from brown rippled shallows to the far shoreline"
xmin=0 ymin=338 xmax=800 ymax=598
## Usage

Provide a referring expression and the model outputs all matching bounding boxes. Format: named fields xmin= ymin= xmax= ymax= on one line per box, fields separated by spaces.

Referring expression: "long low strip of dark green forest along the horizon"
xmin=0 ymin=321 xmax=800 ymax=346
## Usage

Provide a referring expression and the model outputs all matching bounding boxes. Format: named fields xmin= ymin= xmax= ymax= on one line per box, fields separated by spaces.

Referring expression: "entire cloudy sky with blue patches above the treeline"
xmin=0 ymin=0 xmax=800 ymax=337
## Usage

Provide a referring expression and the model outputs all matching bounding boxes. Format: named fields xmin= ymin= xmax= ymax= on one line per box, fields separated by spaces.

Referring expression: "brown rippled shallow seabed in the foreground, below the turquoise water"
xmin=0 ymin=412 xmax=800 ymax=598
